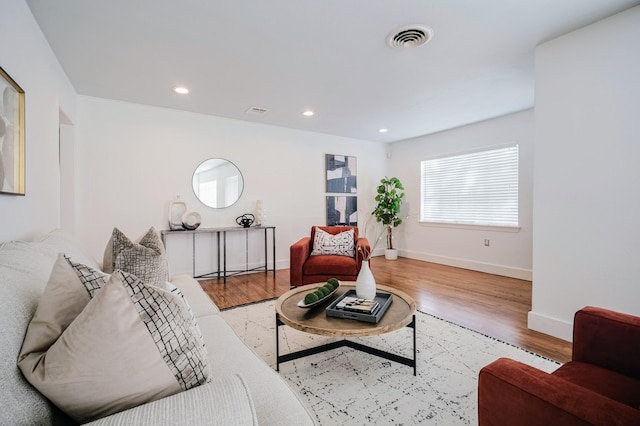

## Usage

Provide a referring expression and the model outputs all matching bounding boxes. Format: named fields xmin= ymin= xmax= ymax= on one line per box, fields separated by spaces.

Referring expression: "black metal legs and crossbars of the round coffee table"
xmin=276 ymin=313 xmax=418 ymax=376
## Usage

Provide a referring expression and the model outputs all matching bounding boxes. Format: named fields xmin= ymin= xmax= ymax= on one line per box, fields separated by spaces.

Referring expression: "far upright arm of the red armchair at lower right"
xmin=572 ymin=306 xmax=640 ymax=379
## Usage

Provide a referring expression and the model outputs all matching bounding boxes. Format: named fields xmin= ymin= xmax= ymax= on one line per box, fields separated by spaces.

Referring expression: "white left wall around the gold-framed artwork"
xmin=0 ymin=0 xmax=76 ymax=241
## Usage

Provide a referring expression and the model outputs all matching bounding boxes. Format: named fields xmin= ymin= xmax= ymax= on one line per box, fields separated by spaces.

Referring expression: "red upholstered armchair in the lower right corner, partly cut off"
xmin=478 ymin=307 xmax=640 ymax=426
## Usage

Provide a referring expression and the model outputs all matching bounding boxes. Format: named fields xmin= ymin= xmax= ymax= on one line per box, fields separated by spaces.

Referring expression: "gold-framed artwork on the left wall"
xmin=0 ymin=68 xmax=25 ymax=195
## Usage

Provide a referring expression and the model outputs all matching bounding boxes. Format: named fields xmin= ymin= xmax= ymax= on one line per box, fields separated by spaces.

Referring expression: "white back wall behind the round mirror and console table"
xmin=76 ymin=96 xmax=386 ymax=273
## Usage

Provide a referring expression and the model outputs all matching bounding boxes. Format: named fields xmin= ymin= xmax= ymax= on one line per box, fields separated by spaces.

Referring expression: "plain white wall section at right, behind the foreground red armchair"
xmin=529 ymin=6 xmax=640 ymax=340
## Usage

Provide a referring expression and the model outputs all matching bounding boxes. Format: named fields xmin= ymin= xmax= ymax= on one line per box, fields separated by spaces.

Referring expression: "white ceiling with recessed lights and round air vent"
xmin=27 ymin=0 xmax=640 ymax=142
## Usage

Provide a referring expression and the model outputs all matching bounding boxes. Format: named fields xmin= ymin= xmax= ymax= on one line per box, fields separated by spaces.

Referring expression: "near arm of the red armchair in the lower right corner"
xmin=478 ymin=358 xmax=640 ymax=426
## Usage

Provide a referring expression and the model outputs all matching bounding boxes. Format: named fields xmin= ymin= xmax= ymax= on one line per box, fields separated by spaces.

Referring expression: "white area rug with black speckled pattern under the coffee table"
xmin=222 ymin=300 xmax=560 ymax=426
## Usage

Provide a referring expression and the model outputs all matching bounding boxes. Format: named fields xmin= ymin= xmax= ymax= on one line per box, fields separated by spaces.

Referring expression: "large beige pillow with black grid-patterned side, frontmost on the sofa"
xmin=19 ymin=270 xmax=210 ymax=422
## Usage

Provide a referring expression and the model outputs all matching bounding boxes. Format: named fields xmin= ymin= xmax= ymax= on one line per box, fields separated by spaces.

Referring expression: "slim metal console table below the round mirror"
xmin=160 ymin=225 xmax=276 ymax=283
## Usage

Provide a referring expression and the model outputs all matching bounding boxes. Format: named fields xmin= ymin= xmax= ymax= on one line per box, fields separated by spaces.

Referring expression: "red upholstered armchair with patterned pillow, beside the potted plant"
xmin=289 ymin=226 xmax=371 ymax=287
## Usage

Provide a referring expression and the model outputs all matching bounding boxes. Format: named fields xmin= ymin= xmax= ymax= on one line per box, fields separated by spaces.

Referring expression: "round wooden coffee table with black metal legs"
xmin=275 ymin=281 xmax=417 ymax=375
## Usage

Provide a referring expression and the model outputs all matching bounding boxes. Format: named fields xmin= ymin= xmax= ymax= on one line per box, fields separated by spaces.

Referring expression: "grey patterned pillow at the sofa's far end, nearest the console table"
xmin=102 ymin=227 xmax=169 ymax=285
